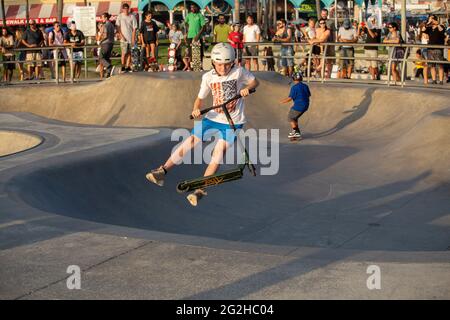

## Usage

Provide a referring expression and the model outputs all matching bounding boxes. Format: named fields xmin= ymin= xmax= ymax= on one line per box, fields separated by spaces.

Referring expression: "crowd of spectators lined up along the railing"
xmin=0 ymin=3 xmax=450 ymax=84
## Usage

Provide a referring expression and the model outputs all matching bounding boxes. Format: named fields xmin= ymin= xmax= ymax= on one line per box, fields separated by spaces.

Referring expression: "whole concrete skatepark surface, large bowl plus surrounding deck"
xmin=0 ymin=73 xmax=450 ymax=299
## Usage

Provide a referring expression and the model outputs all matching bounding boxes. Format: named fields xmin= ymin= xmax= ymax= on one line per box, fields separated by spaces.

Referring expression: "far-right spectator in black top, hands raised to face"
xmin=422 ymin=15 xmax=445 ymax=85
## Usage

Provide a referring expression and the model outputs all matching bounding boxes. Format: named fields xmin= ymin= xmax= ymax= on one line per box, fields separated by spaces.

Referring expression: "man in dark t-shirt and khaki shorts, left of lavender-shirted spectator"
xmin=22 ymin=20 xmax=44 ymax=80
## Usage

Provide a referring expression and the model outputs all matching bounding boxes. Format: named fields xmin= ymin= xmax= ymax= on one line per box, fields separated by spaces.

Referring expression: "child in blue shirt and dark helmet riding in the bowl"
xmin=280 ymin=71 xmax=311 ymax=139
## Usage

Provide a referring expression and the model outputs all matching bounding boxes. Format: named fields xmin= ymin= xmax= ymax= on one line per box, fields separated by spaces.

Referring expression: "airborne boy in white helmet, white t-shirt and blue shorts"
xmin=146 ymin=43 xmax=259 ymax=206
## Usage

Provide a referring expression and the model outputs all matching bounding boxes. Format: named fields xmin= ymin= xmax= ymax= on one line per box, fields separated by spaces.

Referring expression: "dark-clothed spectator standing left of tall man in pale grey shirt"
xmin=99 ymin=12 xmax=115 ymax=79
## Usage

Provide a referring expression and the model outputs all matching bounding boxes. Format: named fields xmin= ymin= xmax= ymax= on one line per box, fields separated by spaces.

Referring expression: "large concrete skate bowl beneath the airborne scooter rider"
xmin=2 ymin=73 xmax=450 ymax=251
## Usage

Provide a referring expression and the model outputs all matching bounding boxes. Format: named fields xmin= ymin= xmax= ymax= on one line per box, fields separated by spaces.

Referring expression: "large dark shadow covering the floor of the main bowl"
xmin=3 ymin=135 xmax=450 ymax=250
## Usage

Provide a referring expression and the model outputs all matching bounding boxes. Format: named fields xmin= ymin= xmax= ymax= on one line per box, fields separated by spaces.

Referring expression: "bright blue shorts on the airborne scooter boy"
xmin=191 ymin=118 xmax=244 ymax=145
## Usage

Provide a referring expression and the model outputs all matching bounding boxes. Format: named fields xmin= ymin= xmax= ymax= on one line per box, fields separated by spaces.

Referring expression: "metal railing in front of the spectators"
xmin=1 ymin=42 xmax=450 ymax=87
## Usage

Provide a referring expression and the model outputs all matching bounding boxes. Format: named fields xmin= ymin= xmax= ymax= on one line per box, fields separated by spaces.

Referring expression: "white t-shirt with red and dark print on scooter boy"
xmin=198 ymin=66 xmax=255 ymax=124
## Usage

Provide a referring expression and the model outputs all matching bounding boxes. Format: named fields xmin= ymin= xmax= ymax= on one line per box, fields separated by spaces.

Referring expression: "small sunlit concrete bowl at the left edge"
xmin=0 ymin=130 xmax=42 ymax=158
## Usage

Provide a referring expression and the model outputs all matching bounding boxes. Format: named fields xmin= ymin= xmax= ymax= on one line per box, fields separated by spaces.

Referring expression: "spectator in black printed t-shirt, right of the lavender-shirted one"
xmin=64 ymin=21 xmax=85 ymax=79
